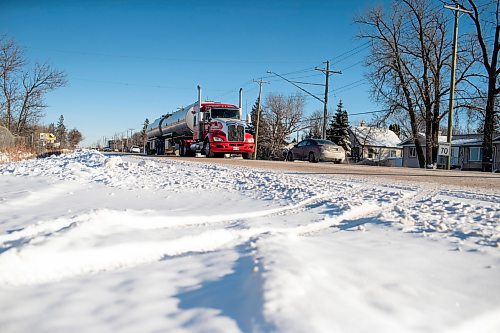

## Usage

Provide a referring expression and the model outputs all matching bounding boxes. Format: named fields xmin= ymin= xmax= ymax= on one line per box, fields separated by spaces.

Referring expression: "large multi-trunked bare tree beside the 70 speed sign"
xmin=356 ymin=0 xmax=472 ymax=167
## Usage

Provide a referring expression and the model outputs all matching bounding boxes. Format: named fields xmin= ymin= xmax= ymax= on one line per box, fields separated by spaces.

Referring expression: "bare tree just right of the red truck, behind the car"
xmin=259 ymin=94 xmax=305 ymax=159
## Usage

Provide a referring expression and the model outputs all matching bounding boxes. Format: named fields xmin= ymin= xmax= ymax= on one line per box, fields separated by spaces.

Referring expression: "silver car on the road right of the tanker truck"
xmin=286 ymin=139 xmax=345 ymax=163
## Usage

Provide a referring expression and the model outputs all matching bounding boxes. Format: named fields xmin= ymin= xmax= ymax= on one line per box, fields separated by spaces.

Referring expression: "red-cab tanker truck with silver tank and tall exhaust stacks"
xmin=144 ymin=86 xmax=255 ymax=159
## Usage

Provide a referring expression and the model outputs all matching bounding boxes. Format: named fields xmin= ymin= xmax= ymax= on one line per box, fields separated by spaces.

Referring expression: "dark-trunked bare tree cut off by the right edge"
xmin=468 ymin=0 xmax=500 ymax=171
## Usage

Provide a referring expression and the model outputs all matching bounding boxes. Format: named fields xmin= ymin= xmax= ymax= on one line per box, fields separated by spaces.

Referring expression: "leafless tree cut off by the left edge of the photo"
xmin=0 ymin=36 xmax=67 ymax=135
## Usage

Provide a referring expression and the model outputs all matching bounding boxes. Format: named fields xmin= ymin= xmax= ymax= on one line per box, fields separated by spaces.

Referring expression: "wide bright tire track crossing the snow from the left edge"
xmin=0 ymin=184 xmax=414 ymax=286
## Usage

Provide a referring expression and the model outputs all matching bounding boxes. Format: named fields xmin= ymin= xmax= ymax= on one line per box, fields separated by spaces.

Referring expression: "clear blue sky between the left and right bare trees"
xmin=0 ymin=0 xmax=388 ymax=145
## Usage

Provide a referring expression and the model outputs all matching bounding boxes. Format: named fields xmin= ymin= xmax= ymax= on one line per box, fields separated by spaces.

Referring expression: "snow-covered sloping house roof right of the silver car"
xmin=350 ymin=126 xmax=401 ymax=148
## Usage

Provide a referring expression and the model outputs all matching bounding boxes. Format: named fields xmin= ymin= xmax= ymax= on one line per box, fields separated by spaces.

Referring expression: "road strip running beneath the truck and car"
xmin=140 ymin=156 xmax=500 ymax=193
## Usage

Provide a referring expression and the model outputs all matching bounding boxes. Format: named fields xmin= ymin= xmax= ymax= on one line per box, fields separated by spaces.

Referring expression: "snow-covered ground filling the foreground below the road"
xmin=0 ymin=151 xmax=500 ymax=333
